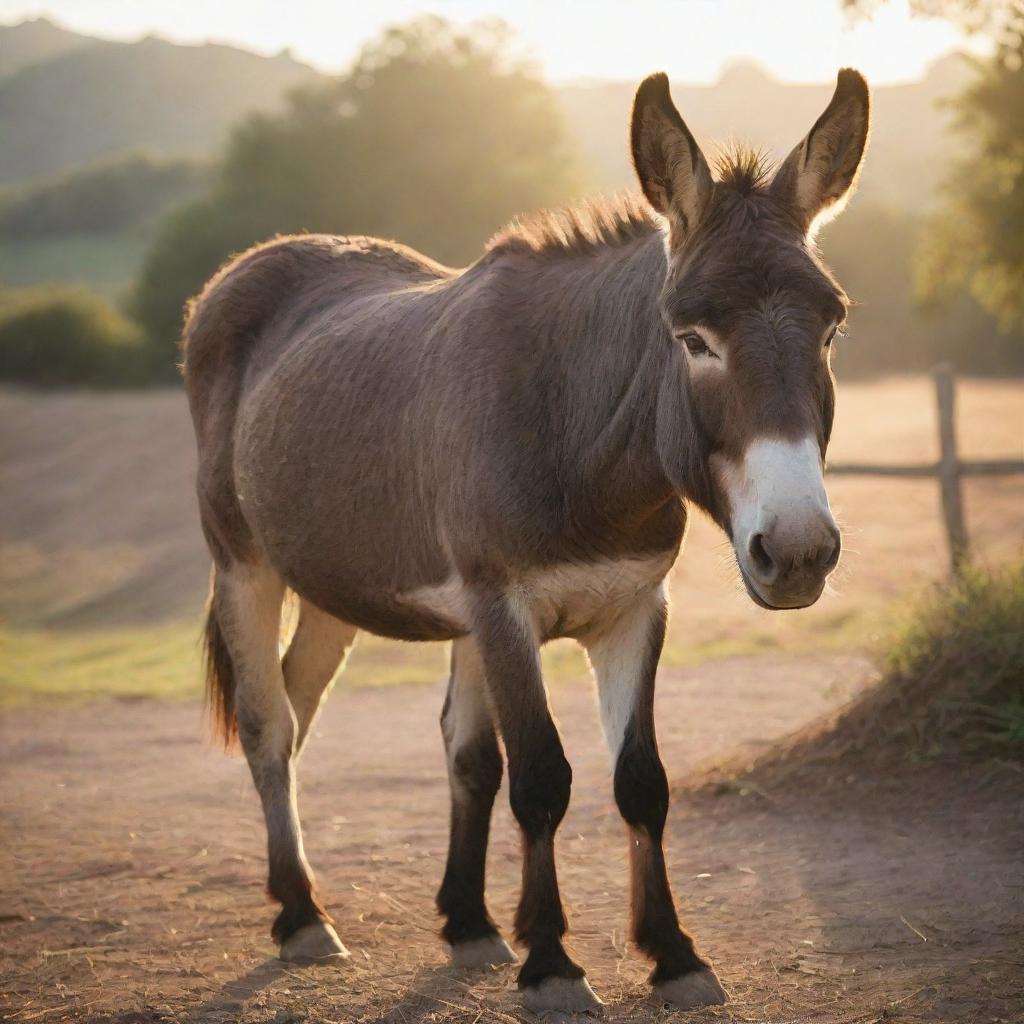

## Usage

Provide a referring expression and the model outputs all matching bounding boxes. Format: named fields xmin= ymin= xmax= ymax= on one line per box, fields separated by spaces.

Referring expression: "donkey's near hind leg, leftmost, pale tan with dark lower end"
xmin=212 ymin=561 xmax=348 ymax=961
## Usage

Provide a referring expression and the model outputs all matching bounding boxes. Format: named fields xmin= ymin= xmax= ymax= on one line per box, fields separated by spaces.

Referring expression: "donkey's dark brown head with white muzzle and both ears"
xmin=632 ymin=70 xmax=868 ymax=608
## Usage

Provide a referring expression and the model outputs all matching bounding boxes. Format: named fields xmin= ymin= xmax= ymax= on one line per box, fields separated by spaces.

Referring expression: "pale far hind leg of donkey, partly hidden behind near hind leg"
xmin=284 ymin=601 xmax=358 ymax=758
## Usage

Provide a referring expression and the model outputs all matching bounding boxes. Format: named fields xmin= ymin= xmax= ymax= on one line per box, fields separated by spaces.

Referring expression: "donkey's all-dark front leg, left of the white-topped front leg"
xmin=474 ymin=594 xmax=601 ymax=1013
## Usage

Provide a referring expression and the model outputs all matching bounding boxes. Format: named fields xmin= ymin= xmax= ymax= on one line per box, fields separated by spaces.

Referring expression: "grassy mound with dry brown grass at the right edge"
xmin=697 ymin=561 xmax=1024 ymax=793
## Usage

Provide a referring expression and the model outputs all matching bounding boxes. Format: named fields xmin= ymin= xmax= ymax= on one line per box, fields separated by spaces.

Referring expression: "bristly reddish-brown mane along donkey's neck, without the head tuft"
xmin=486 ymin=195 xmax=659 ymax=255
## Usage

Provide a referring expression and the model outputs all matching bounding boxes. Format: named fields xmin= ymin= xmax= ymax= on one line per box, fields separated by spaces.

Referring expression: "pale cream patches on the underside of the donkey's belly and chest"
xmin=401 ymin=550 xmax=676 ymax=640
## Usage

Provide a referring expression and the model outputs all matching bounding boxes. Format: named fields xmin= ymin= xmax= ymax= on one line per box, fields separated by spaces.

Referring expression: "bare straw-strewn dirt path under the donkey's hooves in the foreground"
xmin=0 ymin=655 xmax=1024 ymax=1024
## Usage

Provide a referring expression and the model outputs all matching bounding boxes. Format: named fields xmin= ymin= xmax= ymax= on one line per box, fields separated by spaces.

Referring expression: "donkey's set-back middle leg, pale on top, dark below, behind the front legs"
xmin=437 ymin=637 xmax=516 ymax=968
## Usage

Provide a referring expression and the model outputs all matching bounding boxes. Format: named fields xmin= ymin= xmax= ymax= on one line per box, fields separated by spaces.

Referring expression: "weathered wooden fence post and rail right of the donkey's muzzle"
xmin=827 ymin=366 xmax=1024 ymax=574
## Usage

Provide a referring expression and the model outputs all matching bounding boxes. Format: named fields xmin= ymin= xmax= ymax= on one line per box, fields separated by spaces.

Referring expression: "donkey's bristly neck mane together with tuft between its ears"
xmin=486 ymin=144 xmax=775 ymax=255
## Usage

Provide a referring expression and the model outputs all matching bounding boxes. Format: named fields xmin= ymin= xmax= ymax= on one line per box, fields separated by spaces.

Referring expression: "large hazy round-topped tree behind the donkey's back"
xmin=133 ymin=17 xmax=579 ymax=362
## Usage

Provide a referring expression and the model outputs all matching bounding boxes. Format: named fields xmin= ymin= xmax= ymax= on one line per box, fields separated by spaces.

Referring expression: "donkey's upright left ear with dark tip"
xmin=630 ymin=73 xmax=712 ymax=234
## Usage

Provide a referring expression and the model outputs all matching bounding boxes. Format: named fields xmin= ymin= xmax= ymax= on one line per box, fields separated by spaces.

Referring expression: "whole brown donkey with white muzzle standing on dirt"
xmin=183 ymin=70 xmax=869 ymax=1012
